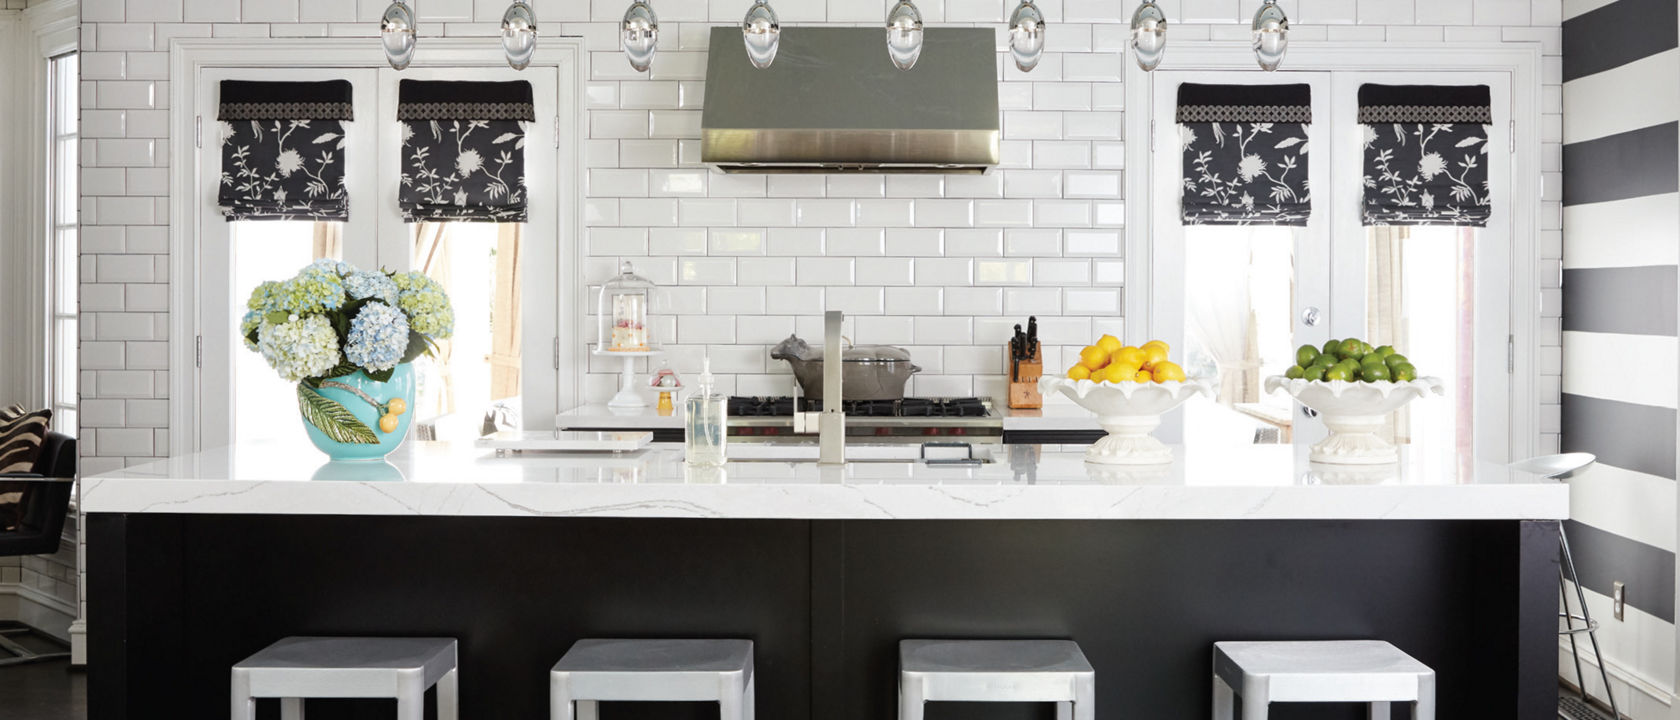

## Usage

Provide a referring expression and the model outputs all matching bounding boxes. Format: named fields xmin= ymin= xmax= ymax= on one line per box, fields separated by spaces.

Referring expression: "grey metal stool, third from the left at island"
xmin=899 ymin=639 xmax=1097 ymax=720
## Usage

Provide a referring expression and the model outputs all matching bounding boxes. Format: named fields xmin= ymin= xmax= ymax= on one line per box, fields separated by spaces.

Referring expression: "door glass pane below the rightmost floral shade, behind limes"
xmin=1364 ymin=227 xmax=1477 ymax=457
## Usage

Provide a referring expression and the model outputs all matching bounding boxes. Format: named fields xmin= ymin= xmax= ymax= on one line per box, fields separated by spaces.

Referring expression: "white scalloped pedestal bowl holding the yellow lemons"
xmin=1038 ymin=374 xmax=1213 ymax=465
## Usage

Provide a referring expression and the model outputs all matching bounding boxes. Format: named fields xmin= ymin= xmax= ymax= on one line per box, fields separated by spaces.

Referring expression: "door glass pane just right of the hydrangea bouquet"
xmin=410 ymin=222 xmax=524 ymax=440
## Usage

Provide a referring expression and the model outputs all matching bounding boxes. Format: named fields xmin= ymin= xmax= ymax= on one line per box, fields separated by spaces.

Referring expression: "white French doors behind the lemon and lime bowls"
xmin=1149 ymin=70 xmax=1519 ymax=462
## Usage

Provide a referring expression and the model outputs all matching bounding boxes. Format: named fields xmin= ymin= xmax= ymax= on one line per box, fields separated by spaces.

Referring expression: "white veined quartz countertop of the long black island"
xmin=82 ymin=443 xmax=1569 ymax=520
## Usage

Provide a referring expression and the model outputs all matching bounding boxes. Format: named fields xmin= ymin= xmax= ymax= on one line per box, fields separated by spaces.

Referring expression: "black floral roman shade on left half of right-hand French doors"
xmin=1178 ymin=82 xmax=1312 ymax=225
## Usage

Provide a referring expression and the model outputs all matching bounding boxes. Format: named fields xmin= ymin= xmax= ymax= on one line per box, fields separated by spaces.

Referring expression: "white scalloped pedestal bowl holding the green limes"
xmin=1265 ymin=376 xmax=1441 ymax=465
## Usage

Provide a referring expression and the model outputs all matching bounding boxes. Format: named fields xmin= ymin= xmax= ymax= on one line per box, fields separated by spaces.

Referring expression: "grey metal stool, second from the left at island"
xmin=549 ymin=639 xmax=754 ymax=720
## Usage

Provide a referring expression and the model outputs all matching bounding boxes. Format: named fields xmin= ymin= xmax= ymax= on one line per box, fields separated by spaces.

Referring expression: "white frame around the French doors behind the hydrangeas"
xmin=170 ymin=37 xmax=588 ymax=455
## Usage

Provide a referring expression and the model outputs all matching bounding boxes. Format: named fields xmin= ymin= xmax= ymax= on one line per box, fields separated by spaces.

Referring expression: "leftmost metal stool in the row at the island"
xmin=232 ymin=638 xmax=459 ymax=718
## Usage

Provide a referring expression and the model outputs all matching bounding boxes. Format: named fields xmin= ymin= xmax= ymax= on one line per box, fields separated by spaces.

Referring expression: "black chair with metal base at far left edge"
xmin=0 ymin=431 xmax=76 ymax=668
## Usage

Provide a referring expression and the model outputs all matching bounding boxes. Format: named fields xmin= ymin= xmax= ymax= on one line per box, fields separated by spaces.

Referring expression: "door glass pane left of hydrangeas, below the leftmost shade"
xmin=228 ymin=220 xmax=344 ymax=443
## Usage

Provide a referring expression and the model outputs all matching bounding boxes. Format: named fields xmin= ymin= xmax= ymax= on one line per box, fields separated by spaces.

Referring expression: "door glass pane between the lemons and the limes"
xmin=1183 ymin=225 xmax=1302 ymax=448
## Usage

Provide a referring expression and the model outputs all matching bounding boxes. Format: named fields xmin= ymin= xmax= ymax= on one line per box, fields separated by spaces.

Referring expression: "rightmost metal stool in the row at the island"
xmin=1213 ymin=639 xmax=1435 ymax=720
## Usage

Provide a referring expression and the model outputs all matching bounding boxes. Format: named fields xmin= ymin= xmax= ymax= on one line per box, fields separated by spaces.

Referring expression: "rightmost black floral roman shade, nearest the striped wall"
xmin=1359 ymin=84 xmax=1494 ymax=227
